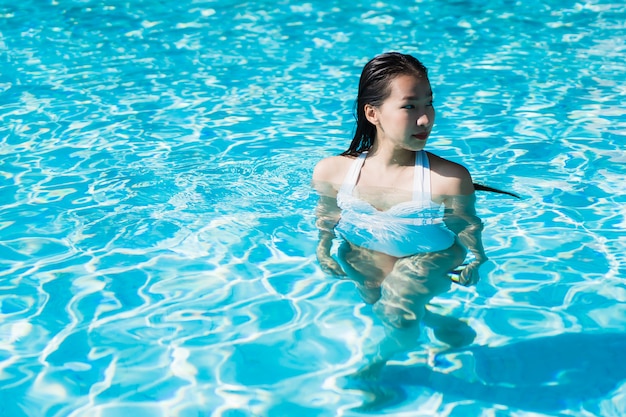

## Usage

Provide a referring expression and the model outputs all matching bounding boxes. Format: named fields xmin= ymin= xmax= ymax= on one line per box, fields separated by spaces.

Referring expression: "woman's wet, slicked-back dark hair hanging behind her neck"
xmin=341 ymin=52 xmax=428 ymax=156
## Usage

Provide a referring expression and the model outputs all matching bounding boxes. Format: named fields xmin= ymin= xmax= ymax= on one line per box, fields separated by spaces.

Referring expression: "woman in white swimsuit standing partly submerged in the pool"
xmin=313 ymin=53 xmax=487 ymax=372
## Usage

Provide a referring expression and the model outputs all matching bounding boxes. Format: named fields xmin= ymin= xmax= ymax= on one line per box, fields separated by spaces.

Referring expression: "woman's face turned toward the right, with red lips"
xmin=366 ymin=75 xmax=435 ymax=151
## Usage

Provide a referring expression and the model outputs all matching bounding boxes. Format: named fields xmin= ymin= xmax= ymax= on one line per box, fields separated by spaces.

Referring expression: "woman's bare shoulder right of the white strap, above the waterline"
xmin=428 ymin=152 xmax=474 ymax=195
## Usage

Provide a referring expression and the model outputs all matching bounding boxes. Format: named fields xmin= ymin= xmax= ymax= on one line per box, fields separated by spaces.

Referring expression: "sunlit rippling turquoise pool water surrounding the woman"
xmin=0 ymin=0 xmax=626 ymax=417
